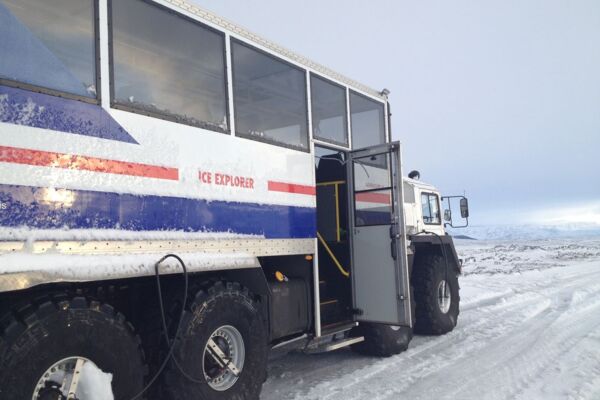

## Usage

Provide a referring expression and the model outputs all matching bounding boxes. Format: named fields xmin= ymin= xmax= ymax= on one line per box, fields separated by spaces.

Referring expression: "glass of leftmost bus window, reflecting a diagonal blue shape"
xmin=0 ymin=0 xmax=96 ymax=98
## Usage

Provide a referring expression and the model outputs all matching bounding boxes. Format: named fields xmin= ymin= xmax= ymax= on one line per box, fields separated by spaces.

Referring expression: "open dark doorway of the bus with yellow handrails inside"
xmin=315 ymin=147 xmax=353 ymax=331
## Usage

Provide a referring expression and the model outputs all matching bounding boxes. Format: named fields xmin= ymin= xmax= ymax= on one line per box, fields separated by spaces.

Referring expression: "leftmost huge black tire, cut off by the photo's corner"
xmin=0 ymin=297 xmax=147 ymax=400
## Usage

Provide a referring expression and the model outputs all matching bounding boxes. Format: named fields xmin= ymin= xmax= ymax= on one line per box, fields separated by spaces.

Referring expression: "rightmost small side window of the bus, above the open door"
xmin=350 ymin=92 xmax=385 ymax=149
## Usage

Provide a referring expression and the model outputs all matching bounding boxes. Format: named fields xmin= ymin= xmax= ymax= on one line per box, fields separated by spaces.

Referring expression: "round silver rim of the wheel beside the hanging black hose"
xmin=202 ymin=325 xmax=246 ymax=392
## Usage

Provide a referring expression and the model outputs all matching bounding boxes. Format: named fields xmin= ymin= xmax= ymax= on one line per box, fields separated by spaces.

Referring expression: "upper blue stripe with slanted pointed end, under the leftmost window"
xmin=0 ymin=86 xmax=138 ymax=144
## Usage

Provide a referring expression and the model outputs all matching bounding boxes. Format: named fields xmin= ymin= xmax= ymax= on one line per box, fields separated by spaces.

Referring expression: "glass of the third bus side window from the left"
xmin=232 ymin=41 xmax=308 ymax=150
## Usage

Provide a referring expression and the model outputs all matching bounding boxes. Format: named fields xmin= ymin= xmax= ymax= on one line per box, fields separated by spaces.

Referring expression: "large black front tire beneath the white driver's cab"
xmin=412 ymin=254 xmax=460 ymax=335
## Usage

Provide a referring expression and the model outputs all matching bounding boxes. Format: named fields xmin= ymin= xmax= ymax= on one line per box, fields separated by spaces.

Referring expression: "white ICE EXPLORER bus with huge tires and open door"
xmin=0 ymin=0 xmax=468 ymax=400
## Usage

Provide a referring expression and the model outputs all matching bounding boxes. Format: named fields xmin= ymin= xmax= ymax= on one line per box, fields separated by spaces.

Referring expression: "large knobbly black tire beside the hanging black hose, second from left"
xmin=164 ymin=282 xmax=268 ymax=400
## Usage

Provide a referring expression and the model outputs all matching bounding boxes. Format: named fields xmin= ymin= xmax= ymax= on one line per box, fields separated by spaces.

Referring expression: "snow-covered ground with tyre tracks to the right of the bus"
xmin=261 ymin=239 xmax=600 ymax=400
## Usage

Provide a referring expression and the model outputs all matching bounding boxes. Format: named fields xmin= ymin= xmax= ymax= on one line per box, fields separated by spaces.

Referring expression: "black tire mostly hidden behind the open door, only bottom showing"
xmin=352 ymin=323 xmax=412 ymax=357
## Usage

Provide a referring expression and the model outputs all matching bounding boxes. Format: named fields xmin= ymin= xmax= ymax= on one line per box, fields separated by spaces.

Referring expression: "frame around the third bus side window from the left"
xmin=230 ymin=37 xmax=312 ymax=153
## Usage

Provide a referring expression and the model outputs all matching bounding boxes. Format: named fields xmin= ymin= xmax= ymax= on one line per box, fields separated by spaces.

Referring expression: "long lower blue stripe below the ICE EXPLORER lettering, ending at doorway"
xmin=0 ymin=185 xmax=316 ymax=239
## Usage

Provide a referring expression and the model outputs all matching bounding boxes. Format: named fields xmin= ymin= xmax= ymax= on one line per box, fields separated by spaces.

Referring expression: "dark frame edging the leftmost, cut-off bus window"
xmin=0 ymin=0 xmax=102 ymax=105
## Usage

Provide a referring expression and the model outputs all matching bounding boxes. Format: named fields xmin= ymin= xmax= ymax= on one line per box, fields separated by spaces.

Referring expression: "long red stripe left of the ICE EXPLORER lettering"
xmin=0 ymin=146 xmax=179 ymax=181
